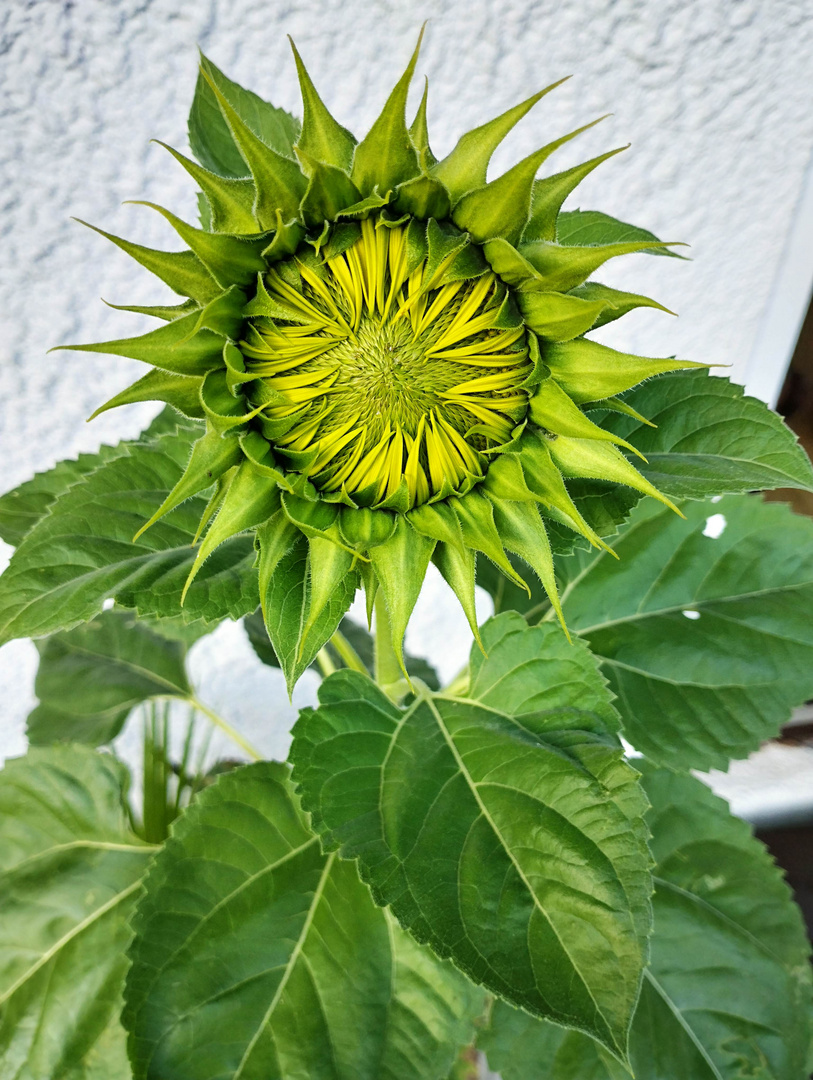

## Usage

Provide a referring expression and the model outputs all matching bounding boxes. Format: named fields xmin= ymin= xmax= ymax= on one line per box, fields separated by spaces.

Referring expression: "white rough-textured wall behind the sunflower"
xmin=0 ymin=0 xmax=813 ymax=752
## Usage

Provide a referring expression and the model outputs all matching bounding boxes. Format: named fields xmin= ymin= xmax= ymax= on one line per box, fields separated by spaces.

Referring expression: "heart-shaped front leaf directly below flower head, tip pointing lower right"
xmin=292 ymin=612 xmax=650 ymax=1057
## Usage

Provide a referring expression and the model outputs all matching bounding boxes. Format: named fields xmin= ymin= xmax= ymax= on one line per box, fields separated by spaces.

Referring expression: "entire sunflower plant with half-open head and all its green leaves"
xmin=0 ymin=29 xmax=813 ymax=1080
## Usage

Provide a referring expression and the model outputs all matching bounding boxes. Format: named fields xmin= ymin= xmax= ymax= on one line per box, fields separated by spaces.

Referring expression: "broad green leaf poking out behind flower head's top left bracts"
xmin=189 ymin=57 xmax=299 ymax=178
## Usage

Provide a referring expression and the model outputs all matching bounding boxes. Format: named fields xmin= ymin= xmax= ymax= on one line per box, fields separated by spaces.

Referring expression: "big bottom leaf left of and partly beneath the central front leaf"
xmin=124 ymin=762 xmax=483 ymax=1080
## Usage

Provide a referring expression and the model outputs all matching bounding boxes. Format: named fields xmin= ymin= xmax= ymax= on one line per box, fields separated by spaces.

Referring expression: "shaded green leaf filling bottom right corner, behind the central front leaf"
xmin=479 ymin=767 xmax=811 ymax=1080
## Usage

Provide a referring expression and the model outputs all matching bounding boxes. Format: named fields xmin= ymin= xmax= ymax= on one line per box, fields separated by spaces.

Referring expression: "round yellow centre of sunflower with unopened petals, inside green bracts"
xmin=241 ymin=219 xmax=531 ymax=509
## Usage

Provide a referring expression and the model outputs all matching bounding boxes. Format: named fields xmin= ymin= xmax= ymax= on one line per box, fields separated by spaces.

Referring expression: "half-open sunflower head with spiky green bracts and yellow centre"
xmin=60 ymin=29 xmax=702 ymax=683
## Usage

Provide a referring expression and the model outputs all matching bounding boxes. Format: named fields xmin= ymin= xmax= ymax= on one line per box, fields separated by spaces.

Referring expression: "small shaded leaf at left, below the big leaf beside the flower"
xmin=28 ymin=611 xmax=191 ymax=746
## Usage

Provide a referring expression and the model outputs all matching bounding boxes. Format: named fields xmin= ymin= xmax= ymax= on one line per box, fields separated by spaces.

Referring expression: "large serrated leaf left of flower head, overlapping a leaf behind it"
xmin=0 ymin=421 xmax=258 ymax=643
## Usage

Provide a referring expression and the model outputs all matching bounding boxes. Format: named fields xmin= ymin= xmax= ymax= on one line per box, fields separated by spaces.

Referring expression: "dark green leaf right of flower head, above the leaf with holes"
xmin=601 ymin=372 xmax=813 ymax=499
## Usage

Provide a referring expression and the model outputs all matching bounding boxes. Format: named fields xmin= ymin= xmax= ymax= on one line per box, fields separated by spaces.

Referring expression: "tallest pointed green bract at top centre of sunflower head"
xmin=352 ymin=30 xmax=423 ymax=195
